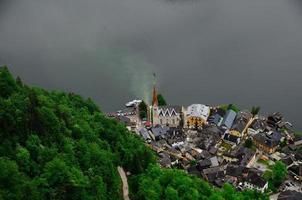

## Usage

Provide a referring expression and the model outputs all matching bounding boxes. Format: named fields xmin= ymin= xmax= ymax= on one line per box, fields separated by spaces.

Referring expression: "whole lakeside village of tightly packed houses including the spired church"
xmin=109 ymin=85 xmax=302 ymax=198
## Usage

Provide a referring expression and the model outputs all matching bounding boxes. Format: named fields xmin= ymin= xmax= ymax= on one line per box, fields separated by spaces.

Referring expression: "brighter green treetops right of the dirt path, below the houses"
xmin=131 ymin=165 xmax=268 ymax=200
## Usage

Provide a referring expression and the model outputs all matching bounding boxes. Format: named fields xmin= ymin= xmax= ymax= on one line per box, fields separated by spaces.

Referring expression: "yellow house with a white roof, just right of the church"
xmin=186 ymin=104 xmax=210 ymax=128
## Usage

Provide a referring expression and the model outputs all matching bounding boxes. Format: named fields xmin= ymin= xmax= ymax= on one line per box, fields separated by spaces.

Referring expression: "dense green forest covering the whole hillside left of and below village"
xmin=0 ymin=67 xmax=267 ymax=200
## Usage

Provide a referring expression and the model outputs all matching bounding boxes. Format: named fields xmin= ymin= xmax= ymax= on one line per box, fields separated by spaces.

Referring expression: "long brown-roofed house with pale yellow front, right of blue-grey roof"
xmin=230 ymin=111 xmax=253 ymax=137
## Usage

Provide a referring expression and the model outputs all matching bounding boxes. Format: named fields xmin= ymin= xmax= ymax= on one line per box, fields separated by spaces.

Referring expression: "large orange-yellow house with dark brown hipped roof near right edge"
xmin=253 ymin=131 xmax=282 ymax=154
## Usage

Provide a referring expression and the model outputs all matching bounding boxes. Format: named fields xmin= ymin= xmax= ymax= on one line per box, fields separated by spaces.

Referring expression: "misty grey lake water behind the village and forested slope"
xmin=0 ymin=0 xmax=302 ymax=130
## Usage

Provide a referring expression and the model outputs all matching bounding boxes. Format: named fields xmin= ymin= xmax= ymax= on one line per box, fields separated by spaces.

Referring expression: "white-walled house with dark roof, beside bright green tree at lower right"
xmin=243 ymin=173 xmax=268 ymax=193
